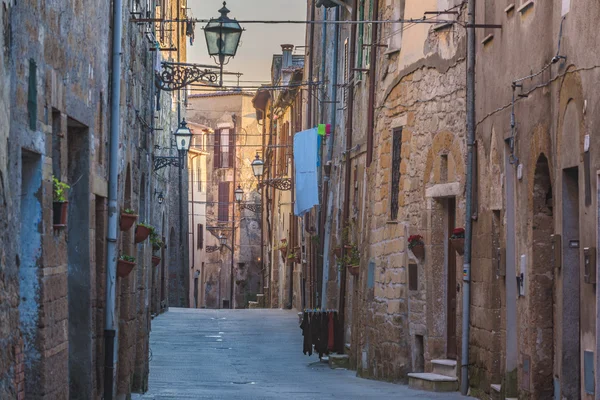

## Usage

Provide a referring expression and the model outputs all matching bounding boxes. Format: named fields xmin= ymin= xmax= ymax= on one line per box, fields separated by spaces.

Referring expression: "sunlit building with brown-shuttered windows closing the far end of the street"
xmin=186 ymin=91 xmax=262 ymax=308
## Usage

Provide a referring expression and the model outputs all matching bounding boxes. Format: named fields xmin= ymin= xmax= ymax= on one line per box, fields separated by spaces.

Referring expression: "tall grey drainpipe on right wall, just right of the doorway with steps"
xmin=460 ymin=0 xmax=475 ymax=396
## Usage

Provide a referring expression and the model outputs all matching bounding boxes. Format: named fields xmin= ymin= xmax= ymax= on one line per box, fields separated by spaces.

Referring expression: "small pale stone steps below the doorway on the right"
xmin=408 ymin=360 xmax=458 ymax=392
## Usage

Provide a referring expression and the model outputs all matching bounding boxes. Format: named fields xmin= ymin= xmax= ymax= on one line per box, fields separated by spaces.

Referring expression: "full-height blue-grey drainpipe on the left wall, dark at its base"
xmin=104 ymin=0 xmax=123 ymax=400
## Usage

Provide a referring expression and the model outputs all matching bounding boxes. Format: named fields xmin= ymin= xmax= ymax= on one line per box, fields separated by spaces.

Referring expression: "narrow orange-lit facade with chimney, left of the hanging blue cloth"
xmin=253 ymin=44 xmax=310 ymax=310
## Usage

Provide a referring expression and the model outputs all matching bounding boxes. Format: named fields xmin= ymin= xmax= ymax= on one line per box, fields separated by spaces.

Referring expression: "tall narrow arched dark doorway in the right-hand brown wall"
xmin=528 ymin=153 xmax=556 ymax=399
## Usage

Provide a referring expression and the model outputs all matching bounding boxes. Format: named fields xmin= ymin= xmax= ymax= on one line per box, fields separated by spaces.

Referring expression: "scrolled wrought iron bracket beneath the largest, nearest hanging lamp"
xmin=156 ymin=62 xmax=221 ymax=92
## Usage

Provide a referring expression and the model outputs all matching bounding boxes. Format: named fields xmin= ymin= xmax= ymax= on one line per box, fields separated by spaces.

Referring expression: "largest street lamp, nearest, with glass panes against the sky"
xmin=204 ymin=1 xmax=244 ymax=86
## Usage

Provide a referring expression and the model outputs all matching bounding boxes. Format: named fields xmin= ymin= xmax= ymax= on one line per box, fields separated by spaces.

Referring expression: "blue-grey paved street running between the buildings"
xmin=133 ymin=308 xmax=465 ymax=400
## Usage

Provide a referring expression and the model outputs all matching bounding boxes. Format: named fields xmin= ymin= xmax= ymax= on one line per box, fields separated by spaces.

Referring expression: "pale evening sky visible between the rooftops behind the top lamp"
xmin=187 ymin=0 xmax=307 ymax=86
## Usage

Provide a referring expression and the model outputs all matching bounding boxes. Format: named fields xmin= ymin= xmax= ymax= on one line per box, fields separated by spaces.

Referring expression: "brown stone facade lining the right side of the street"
xmin=266 ymin=0 xmax=600 ymax=399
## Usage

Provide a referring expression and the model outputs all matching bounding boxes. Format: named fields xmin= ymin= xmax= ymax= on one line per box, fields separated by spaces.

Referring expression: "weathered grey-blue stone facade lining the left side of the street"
xmin=0 ymin=2 xmax=186 ymax=399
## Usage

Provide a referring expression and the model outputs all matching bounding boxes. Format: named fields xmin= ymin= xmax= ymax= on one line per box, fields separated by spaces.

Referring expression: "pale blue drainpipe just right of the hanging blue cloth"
xmin=322 ymin=7 xmax=340 ymax=308
